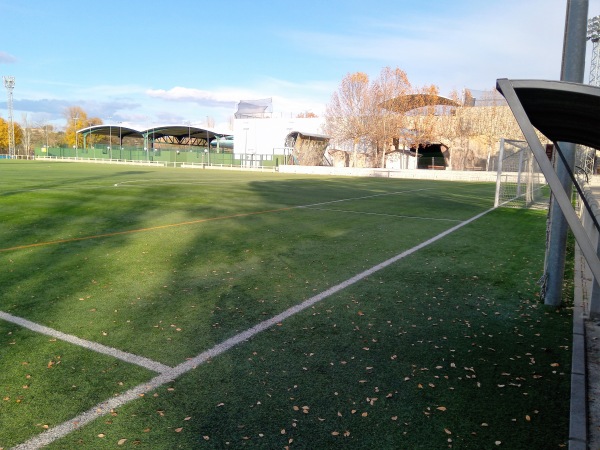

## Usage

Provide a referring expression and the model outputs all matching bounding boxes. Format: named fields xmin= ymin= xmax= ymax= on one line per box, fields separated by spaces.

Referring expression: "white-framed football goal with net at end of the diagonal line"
xmin=494 ymin=139 xmax=549 ymax=208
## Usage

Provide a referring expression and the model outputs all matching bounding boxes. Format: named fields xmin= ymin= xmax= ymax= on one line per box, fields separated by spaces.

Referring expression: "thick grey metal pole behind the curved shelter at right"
xmin=542 ymin=0 xmax=589 ymax=306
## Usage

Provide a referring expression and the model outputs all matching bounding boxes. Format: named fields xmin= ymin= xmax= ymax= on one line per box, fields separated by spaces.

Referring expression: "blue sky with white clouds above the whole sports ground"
xmin=0 ymin=0 xmax=600 ymax=131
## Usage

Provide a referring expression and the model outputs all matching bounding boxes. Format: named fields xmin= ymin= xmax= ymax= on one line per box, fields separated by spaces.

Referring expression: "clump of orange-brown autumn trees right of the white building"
xmin=325 ymin=71 xmax=522 ymax=170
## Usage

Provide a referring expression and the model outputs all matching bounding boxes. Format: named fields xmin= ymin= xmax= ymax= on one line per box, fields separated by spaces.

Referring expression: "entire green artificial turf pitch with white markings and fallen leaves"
xmin=0 ymin=161 xmax=571 ymax=449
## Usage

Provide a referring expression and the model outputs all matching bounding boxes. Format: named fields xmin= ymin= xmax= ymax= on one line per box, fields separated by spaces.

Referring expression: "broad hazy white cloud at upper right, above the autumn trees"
xmin=288 ymin=0 xmax=576 ymax=93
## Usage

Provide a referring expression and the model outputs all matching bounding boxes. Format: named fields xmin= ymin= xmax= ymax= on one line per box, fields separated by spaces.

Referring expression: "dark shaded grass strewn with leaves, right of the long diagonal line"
xmin=47 ymin=207 xmax=570 ymax=449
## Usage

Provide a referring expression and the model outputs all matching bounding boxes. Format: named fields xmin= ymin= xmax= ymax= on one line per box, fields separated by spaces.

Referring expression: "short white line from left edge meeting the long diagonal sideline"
xmin=0 ymin=311 xmax=172 ymax=373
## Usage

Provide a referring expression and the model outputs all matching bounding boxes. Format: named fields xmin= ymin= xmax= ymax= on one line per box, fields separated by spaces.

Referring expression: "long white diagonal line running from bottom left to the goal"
xmin=13 ymin=208 xmax=495 ymax=450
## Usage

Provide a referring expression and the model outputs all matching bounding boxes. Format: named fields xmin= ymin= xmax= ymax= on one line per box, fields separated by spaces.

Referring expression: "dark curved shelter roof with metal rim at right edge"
xmin=497 ymin=80 xmax=600 ymax=150
